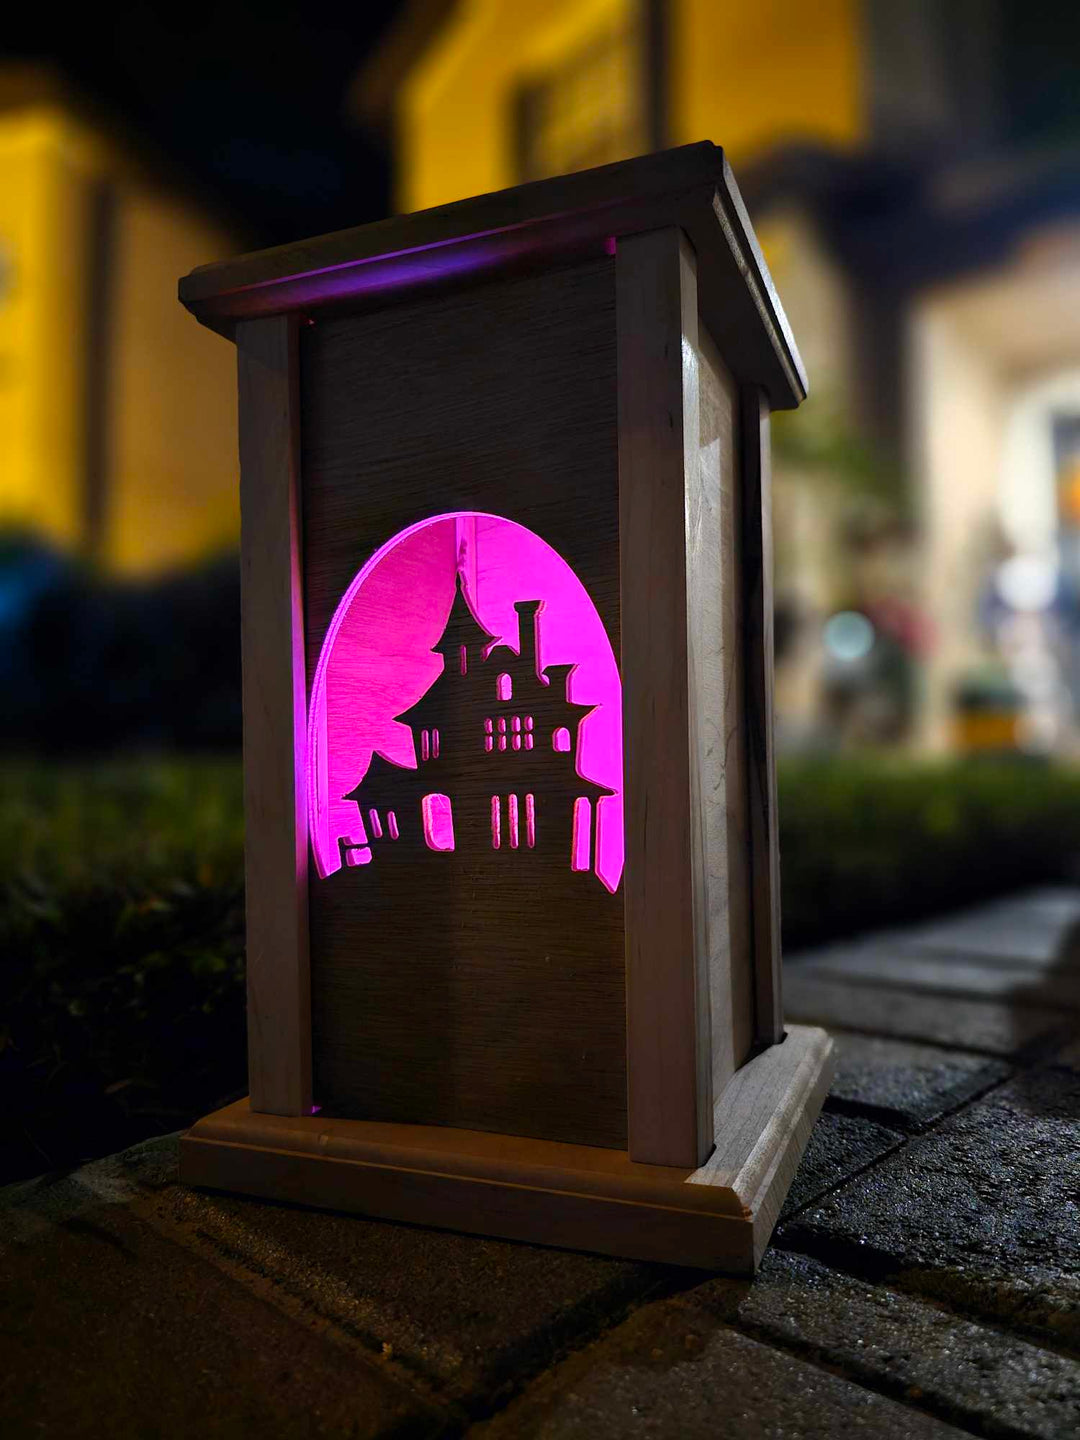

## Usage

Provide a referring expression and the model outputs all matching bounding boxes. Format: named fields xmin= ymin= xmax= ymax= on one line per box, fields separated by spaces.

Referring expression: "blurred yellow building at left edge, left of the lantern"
xmin=0 ymin=69 xmax=239 ymax=573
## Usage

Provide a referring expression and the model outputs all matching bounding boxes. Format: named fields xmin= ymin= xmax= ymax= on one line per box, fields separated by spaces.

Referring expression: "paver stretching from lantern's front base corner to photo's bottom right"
xmin=687 ymin=1250 xmax=1080 ymax=1440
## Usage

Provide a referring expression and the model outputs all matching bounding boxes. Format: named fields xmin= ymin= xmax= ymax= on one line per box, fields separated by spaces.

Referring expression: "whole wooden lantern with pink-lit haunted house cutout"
xmin=180 ymin=144 xmax=831 ymax=1270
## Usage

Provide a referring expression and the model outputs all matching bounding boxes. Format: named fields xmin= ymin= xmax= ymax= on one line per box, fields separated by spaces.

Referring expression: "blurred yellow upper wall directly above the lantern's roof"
xmin=396 ymin=0 xmax=864 ymax=210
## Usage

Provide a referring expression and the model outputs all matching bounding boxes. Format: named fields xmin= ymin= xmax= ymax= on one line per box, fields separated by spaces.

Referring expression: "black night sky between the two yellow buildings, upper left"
xmin=0 ymin=0 xmax=400 ymax=245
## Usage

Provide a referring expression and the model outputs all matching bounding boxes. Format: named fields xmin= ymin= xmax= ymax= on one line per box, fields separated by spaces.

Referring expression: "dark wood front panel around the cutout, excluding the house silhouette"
xmin=301 ymin=250 xmax=626 ymax=1146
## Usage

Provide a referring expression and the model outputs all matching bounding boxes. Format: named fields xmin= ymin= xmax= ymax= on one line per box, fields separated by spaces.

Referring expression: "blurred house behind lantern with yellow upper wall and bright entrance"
xmin=360 ymin=0 xmax=1080 ymax=750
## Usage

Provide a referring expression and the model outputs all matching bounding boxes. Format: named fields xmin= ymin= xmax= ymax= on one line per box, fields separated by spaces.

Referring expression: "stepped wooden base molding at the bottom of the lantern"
xmin=180 ymin=1025 xmax=832 ymax=1274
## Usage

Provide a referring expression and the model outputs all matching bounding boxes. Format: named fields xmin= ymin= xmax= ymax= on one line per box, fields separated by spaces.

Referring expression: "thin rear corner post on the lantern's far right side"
xmin=740 ymin=386 xmax=783 ymax=1045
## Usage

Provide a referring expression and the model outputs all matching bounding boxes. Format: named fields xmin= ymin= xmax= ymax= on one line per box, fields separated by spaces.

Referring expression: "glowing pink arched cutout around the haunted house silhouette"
xmin=308 ymin=511 xmax=624 ymax=890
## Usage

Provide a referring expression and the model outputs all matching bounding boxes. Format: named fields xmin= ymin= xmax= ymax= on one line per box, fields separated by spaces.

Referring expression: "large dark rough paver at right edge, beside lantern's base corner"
xmin=780 ymin=1068 xmax=1080 ymax=1349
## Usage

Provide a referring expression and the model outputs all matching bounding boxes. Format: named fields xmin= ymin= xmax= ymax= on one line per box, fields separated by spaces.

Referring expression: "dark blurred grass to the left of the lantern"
xmin=0 ymin=759 xmax=246 ymax=1181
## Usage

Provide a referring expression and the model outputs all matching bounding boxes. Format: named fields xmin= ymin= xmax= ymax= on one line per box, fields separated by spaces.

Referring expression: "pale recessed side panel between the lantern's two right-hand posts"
xmin=687 ymin=325 xmax=755 ymax=1094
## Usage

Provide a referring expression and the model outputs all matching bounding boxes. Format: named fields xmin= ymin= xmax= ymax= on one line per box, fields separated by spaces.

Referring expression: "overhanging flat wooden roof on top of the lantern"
xmin=180 ymin=141 xmax=806 ymax=409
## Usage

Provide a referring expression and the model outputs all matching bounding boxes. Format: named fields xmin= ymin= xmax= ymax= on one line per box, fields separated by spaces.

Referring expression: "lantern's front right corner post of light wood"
xmin=616 ymin=228 xmax=713 ymax=1168
